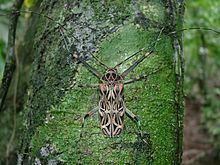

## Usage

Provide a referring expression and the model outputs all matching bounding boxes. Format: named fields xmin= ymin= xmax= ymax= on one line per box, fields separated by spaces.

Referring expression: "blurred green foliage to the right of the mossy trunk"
xmin=184 ymin=0 xmax=220 ymax=149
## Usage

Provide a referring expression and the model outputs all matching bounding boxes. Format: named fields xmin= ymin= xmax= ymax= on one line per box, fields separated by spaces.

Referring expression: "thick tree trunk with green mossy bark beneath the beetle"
xmin=19 ymin=0 xmax=183 ymax=165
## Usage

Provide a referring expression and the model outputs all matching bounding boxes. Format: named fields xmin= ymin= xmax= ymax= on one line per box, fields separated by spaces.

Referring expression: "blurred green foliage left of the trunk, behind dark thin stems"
xmin=0 ymin=0 xmax=34 ymax=164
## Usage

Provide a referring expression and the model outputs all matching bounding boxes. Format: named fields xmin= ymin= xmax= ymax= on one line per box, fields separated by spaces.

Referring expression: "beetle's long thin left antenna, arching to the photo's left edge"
xmin=0 ymin=9 xmax=109 ymax=69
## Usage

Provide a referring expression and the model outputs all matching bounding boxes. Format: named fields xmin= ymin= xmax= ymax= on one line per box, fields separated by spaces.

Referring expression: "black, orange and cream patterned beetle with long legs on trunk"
xmin=62 ymin=28 xmax=164 ymax=137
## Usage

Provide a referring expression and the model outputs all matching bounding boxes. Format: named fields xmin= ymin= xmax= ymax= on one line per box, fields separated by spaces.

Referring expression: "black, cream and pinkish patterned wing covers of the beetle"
xmin=99 ymin=83 xmax=125 ymax=137
